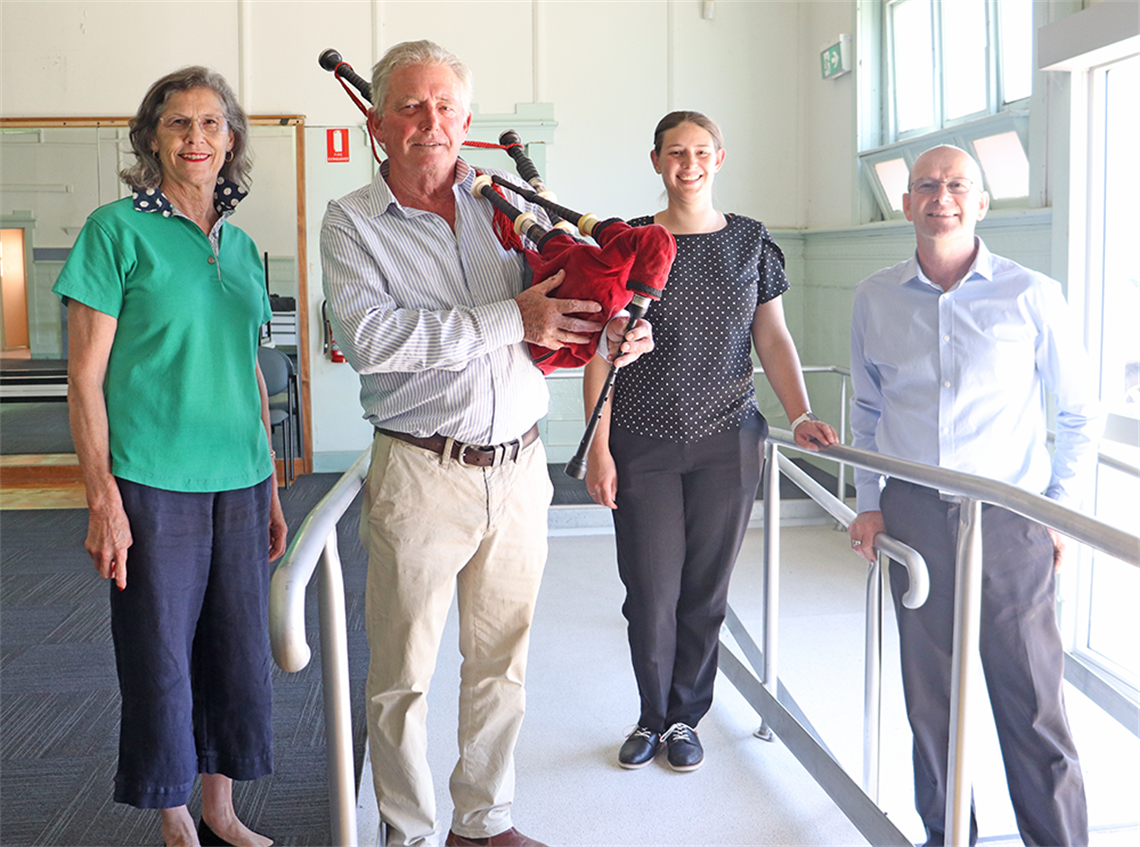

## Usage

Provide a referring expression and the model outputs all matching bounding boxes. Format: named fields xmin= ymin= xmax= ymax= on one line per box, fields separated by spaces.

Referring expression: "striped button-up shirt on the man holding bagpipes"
xmin=320 ymin=160 xmax=548 ymax=445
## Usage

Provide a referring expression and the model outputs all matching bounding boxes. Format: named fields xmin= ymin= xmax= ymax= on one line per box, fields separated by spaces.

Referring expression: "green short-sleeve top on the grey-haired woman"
xmin=52 ymin=193 xmax=272 ymax=491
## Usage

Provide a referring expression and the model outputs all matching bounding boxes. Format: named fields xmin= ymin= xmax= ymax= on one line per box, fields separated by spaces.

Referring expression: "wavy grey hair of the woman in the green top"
xmin=119 ymin=65 xmax=253 ymax=190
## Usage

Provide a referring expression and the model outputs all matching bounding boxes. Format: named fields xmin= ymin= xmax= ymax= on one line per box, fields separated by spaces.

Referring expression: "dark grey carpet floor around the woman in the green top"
xmin=0 ymin=474 xmax=367 ymax=847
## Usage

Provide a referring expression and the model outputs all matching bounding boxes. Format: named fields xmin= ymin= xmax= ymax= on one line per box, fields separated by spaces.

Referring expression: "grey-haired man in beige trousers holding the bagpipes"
xmin=321 ymin=41 xmax=653 ymax=847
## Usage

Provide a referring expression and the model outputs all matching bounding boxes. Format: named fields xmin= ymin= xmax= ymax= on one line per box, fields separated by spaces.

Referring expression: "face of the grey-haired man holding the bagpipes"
xmin=368 ymin=65 xmax=471 ymax=182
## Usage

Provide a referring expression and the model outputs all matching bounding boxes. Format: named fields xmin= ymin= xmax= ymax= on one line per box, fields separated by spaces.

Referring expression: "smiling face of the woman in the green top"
xmin=150 ymin=88 xmax=234 ymax=195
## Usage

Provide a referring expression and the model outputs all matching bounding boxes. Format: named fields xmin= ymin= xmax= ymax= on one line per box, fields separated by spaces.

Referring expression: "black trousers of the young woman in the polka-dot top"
xmin=610 ymin=416 xmax=767 ymax=732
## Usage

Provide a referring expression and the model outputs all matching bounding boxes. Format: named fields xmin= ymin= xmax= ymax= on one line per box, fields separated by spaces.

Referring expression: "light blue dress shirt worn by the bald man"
xmin=852 ymin=238 xmax=1104 ymax=512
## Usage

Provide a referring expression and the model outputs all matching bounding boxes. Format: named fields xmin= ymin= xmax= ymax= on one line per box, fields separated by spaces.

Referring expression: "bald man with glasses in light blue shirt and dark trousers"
xmin=849 ymin=146 xmax=1101 ymax=845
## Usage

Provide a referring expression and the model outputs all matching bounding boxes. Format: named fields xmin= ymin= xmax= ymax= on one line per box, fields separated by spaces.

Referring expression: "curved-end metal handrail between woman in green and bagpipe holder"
xmin=269 ymin=448 xmax=372 ymax=847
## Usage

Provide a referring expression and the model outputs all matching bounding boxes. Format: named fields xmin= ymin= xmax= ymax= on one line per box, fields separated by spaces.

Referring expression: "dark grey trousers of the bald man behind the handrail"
xmin=880 ymin=480 xmax=1089 ymax=847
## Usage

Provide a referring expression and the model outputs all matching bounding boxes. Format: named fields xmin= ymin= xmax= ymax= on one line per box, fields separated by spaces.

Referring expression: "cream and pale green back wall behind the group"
xmin=0 ymin=0 xmax=1071 ymax=466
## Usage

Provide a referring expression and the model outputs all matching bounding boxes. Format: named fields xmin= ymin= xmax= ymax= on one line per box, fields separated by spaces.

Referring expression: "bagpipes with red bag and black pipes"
xmin=318 ymin=49 xmax=677 ymax=479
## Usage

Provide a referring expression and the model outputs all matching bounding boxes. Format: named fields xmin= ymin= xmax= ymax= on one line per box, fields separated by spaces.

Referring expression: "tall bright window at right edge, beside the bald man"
xmin=1036 ymin=2 xmax=1140 ymax=732
